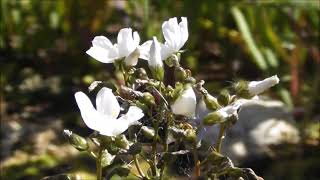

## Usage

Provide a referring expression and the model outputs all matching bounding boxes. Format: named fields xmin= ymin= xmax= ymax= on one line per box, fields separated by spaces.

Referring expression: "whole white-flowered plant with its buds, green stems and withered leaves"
xmin=64 ymin=17 xmax=279 ymax=180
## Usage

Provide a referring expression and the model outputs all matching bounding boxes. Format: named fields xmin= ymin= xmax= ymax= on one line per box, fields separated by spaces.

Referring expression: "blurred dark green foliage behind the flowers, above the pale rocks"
xmin=0 ymin=0 xmax=320 ymax=180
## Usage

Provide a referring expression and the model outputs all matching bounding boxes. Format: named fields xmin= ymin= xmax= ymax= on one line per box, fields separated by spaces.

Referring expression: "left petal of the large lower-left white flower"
xmin=74 ymin=92 xmax=105 ymax=130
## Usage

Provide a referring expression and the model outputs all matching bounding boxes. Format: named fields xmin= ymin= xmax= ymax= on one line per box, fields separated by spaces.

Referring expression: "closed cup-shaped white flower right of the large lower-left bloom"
xmin=171 ymin=86 xmax=197 ymax=117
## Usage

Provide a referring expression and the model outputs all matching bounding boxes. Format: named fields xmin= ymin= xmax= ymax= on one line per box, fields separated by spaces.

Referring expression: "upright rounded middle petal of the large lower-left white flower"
xmin=96 ymin=87 xmax=120 ymax=119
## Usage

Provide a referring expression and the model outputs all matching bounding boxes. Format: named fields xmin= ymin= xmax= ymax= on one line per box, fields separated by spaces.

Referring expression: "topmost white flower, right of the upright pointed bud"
xmin=161 ymin=17 xmax=189 ymax=60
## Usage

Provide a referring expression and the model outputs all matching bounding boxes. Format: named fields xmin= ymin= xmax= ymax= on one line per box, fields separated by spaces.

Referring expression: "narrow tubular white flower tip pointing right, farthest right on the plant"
xmin=248 ymin=75 xmax=279 ymax=95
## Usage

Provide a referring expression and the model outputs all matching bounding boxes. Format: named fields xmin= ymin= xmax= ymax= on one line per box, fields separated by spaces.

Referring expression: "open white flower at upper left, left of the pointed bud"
xmin=86 ymin=28 xmax=150 ymax=66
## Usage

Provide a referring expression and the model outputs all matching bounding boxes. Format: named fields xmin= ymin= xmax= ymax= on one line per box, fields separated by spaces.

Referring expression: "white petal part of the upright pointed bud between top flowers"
xmin=148 ymin=36 xmax=163 ymax=68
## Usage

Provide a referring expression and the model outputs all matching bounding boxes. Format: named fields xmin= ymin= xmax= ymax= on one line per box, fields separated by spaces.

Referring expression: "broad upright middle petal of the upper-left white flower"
xmin=117 ymin=28 xmax=136 ymax=58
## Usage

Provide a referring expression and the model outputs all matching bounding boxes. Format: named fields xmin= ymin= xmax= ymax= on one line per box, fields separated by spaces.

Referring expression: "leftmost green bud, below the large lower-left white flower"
xmin=63 ymin=129 xmax=89 ymax=151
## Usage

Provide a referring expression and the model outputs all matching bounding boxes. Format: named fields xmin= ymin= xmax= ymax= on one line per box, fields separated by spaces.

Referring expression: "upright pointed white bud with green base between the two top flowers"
xmin=148 ymin=37 xmax=164 ymax=81
